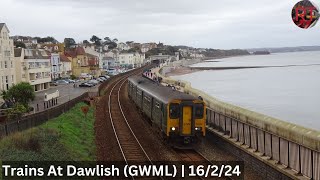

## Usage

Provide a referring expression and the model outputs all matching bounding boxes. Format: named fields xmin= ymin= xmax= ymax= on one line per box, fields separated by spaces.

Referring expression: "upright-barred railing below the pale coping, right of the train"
xmin=207 ymin=108 xmax=320 ymax=180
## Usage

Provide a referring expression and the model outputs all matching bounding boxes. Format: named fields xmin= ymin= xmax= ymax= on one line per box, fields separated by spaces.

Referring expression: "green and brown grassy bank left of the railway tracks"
xmin=0 ymin=103 xmax=96 ymax=161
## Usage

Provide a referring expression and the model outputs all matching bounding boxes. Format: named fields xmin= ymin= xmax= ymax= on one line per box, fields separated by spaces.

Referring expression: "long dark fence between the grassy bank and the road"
xmin=0 ymin=92 xmax=89 ymax=137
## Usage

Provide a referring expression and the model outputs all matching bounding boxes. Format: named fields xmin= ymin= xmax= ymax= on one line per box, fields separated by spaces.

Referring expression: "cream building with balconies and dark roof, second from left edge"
xmin=14 ymin=48 xmax=51 ymax=91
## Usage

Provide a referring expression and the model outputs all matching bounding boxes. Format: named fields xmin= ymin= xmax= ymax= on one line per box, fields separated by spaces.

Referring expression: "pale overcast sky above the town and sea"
xmin=0 ymin=0 xmax=320 ymax=49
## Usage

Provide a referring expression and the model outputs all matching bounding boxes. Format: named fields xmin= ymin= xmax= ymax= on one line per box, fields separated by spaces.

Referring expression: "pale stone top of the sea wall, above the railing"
xmin=156 ymin=67 xmax=320 ymax=152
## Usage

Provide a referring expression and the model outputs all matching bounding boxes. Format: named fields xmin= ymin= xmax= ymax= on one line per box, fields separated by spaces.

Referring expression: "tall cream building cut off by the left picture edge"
xmin=0 ymin=23 xmax=16 ymax=97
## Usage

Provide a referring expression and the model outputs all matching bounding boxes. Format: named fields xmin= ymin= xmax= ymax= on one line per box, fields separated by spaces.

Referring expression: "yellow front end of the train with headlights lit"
xmin=167 ymin=100 xmax=206 ymax=147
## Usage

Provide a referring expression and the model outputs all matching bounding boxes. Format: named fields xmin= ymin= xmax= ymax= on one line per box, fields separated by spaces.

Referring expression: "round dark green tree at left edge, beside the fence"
xmin=1 ymin=82 xmax=35 ymax=109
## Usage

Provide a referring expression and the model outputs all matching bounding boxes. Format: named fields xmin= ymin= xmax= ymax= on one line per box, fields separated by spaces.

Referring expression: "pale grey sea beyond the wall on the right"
xmin=172 ymin=51 xmax=320 ymax=131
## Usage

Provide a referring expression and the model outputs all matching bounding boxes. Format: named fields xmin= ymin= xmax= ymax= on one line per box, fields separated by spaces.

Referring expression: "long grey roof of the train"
xmin=128 ymin=76 xmax=197 ymax=104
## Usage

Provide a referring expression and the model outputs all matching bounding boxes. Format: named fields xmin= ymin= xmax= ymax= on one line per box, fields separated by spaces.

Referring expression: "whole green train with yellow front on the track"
xmin=128 ymin=75 xmax=206 ymax=149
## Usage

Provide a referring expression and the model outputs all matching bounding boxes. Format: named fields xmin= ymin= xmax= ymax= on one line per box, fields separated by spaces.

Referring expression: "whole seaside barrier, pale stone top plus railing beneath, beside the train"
xmin=157 ymin=65 xmax=320 ymax=180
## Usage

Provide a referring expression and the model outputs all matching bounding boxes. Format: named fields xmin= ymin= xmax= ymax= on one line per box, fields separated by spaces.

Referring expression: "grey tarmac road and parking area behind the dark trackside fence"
xmin=30 ymin=83 xmax=100 ymax=113
